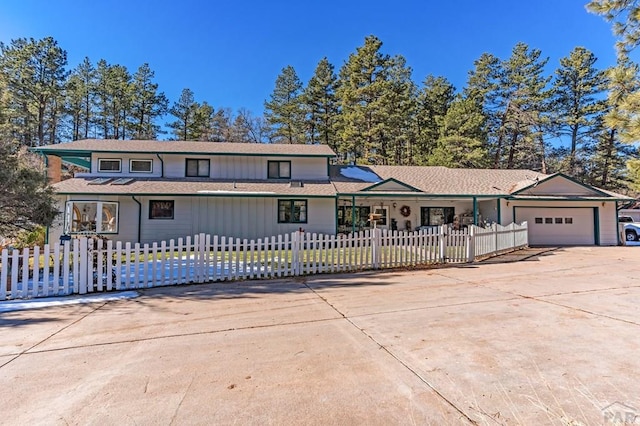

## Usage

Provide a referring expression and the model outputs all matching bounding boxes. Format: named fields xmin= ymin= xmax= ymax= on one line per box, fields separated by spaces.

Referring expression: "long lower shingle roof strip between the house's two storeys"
xmin=53 ymin=178 xmax=336 ymax=197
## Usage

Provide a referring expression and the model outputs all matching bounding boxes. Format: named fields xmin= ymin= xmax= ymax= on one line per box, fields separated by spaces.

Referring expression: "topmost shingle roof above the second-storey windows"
xmin=34 ymin=139 xmax=336 ymax=157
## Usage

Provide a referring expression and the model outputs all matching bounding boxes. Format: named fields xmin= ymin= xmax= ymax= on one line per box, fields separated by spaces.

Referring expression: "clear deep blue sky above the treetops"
xmin=0 ymin=0 xmax=615 ymax=115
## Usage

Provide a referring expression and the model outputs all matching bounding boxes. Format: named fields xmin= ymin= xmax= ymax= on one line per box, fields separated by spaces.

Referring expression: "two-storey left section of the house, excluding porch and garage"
xmin=39 ymin=140 xmax=335 ymax=242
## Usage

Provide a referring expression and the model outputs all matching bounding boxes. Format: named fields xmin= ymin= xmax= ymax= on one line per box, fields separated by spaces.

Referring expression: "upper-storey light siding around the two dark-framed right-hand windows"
xmin=164 ymin=155 xmax=328 ymax=180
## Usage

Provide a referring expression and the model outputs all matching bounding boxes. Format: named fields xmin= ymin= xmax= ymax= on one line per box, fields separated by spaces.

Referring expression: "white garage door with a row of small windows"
xmin=515 ymin=207 xmax=596 ymax=245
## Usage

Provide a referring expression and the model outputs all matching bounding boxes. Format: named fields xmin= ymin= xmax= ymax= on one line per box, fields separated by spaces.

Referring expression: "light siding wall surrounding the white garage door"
xmin=501 ymin=200 xmax=618 ymax=246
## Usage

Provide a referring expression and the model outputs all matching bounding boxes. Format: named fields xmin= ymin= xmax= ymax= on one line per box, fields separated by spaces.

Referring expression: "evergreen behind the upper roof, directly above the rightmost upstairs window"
xmin=264 ymin=65 xmax=305 ymax=143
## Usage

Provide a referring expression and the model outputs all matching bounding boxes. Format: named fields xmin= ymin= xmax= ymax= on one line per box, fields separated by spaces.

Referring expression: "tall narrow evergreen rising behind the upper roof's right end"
xmin=303 ymin=57 xmax=339 ymax=150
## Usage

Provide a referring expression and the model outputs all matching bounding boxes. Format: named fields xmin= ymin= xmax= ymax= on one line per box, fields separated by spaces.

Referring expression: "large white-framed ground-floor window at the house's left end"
xmin=64 ymin=201 xmax=118 ymax=234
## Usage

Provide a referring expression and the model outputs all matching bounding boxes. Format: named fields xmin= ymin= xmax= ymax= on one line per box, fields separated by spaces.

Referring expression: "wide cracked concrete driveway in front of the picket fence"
xmin=0 ymin=247 xmax=640 ymax=425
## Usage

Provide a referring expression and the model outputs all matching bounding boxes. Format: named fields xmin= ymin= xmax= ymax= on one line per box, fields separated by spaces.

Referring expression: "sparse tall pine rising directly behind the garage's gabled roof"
xmin=551 ymin=47 xmax=606 ymax=176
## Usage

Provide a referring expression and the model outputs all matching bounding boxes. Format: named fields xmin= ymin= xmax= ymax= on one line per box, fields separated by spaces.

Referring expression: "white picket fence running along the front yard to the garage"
xmin=0 ymin=224 xmax=527 ymax=300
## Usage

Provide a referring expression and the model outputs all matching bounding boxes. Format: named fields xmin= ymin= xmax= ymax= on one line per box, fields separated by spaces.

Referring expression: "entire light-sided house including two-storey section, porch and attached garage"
xmin=35 ymin=140 xmax=631 ymax=245
